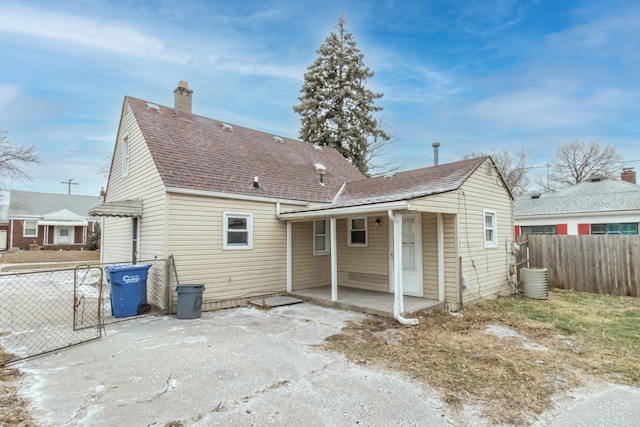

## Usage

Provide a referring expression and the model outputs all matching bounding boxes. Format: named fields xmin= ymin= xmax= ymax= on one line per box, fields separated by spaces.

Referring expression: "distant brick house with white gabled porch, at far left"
xmin=7 ymin=190 xmax=101 ymax=249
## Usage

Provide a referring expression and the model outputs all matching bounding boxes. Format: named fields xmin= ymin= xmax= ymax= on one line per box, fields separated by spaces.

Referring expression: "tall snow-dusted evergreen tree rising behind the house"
xmin=293 ymin=12 xmax=390 ymax=175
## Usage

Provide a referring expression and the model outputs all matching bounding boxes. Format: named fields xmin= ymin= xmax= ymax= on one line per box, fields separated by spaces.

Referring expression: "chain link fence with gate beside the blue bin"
xmin=0 ymin=259 xmax=171 ymax=366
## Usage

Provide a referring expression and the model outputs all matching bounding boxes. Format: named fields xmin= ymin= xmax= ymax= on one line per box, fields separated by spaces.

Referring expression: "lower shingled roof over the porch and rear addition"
xmin=282 ymin=157 xmax=488 ymax=212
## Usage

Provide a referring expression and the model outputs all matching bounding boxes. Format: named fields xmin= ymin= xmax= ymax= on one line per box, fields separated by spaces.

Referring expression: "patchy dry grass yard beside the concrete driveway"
xmin=325 ymin=292 xmax=640 ymax=425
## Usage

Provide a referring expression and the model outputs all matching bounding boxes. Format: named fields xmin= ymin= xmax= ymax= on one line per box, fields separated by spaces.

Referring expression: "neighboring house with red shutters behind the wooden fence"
xmin=515 ymin=169 xmax=640 ymax=237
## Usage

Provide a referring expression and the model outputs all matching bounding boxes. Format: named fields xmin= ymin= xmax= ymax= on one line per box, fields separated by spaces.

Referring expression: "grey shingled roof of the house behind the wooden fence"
xmin=514 ymin=177 xmax=640 ymax=218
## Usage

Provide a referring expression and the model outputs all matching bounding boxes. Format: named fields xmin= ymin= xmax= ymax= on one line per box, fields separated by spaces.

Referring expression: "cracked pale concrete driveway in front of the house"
xmin=18 ymin=304 xmax=455 ymax=426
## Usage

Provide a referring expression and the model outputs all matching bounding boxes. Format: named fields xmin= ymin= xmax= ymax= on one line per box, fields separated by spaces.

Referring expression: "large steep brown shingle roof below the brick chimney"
xmin=125 ymin=97 xmax=364 ymax=203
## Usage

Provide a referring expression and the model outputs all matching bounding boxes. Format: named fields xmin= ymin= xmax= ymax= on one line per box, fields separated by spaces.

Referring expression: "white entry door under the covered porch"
xmin=402 ymin=214 xmax=423 ymax=297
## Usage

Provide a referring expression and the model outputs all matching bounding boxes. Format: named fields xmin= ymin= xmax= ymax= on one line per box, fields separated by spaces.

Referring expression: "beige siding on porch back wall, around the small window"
xmin=336 ymin=216 xmax=389 ymax=292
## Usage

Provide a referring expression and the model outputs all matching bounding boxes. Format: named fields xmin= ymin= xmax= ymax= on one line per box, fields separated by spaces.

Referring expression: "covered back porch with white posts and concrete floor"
xmin=279 ymin=201 xmax=458 ymax=324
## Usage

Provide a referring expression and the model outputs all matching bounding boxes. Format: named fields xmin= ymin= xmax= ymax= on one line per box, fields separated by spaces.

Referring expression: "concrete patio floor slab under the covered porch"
xmin=289 ymin=285 xmax=444 ymax=318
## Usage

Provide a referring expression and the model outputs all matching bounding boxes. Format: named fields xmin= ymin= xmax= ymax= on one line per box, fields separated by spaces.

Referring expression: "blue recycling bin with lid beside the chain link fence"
xmin=105 ymin=264 xmax=151 ymax=317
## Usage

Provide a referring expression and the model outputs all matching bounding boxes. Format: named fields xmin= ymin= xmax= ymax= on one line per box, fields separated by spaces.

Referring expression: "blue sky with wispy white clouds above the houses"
xmin=0 ymin=0 xmax=640 ymax=195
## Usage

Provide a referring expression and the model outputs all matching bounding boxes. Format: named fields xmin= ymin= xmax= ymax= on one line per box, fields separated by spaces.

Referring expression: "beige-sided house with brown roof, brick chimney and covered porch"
xmin=92 ymin=82 xmax=513 ymax=318
